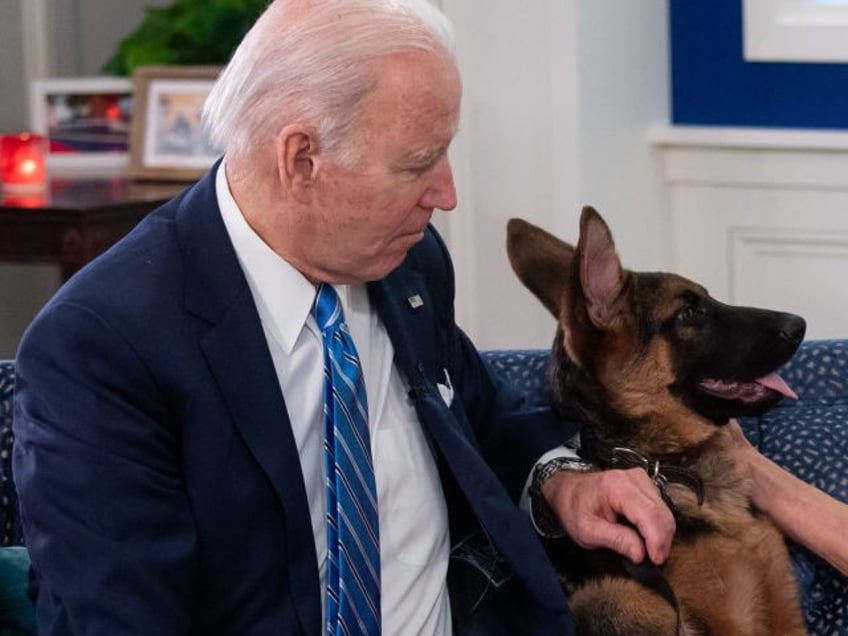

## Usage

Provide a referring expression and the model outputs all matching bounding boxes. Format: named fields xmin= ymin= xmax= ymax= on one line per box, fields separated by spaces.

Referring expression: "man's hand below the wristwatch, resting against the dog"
xmin=541 ymin=468 xmax=675 ymax=563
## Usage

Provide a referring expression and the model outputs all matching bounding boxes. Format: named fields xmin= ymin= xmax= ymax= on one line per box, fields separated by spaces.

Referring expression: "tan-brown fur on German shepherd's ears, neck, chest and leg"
xmin=508 ymin=209 xmax=806 ymax=636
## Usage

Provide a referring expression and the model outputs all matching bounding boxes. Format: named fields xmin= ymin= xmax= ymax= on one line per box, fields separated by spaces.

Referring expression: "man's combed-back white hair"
xmin=203 ymin=0 xmax=454 ymax=163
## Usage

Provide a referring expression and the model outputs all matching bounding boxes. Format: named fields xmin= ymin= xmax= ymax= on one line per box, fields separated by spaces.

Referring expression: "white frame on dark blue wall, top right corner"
xmin=743 ymin=0 xmax=848 ymax=62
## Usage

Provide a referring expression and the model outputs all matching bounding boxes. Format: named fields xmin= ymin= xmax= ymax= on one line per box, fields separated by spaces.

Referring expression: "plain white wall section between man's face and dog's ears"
xmin=443 ymin=0 xmax=579 ymax=347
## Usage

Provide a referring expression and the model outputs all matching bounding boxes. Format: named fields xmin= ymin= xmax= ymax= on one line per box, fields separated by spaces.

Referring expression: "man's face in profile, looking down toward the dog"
xmin=310 ymin=52 xmax=461 ymax=283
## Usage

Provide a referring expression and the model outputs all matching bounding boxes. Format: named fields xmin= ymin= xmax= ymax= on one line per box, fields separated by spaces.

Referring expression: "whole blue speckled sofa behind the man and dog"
xmin=0 ymin=340 xmax=848 ymax=636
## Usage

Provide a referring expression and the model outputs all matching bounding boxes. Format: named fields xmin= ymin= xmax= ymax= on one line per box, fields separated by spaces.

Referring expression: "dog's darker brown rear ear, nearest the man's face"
xmin=506 ymin=219 xmax=574 ymax=318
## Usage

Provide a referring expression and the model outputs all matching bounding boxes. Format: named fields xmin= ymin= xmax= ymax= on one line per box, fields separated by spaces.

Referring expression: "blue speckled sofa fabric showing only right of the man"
xmin=484 ymin=340 xmax=848 ymax=636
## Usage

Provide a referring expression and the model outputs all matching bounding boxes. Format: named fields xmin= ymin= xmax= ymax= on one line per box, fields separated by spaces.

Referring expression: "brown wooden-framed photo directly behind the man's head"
xmin=130 ymin=66 xmax=221 ymax=181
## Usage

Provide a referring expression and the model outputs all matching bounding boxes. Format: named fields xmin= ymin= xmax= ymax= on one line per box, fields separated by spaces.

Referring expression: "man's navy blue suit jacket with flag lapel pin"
xmin=14 ymin=170 xmax=573 ymax=636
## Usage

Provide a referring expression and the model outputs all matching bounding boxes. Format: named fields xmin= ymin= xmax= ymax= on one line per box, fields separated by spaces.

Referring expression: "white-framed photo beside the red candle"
xmin=30 ymin=77 xmax=133 ymax=174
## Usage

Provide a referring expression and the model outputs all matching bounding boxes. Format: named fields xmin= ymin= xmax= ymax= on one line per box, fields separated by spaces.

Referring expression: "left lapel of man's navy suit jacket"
xmin=177 ymin=170 xmax=321 ymax=633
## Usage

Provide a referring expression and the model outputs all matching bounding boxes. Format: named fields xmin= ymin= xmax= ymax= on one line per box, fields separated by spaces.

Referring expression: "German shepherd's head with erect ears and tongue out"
xmin=507 ymin=207 xmax=806 ymax=452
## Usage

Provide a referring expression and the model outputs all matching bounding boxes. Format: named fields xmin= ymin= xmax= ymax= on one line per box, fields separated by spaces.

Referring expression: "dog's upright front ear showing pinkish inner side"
xmin=577 ymin=206 xmax=624 ymax=329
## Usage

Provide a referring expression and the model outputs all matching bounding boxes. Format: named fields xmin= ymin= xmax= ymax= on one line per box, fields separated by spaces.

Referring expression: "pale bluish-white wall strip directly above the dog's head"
xmin=580 ymin=0 xmax=672 ymax=270
